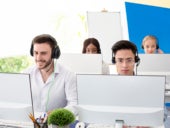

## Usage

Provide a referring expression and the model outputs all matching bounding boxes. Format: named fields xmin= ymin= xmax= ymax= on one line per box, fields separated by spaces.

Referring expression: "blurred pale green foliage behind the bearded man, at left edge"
xmin=0 ymin=56 xmax=32 ymax=73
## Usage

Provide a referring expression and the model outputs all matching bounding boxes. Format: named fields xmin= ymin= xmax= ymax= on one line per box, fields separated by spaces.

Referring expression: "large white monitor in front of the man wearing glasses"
xmin=77 ymin=74 xmax=165 ymax=127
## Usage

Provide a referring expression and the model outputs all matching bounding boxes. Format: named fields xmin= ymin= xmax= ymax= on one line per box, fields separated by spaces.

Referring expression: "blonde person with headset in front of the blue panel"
xmin=142 ymin=35 xmax=163 ymax=54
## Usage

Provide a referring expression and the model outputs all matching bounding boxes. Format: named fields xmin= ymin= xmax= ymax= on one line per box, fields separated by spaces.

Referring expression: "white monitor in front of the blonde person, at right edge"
xmin=137 ymin=54 xmax=170 ymax=75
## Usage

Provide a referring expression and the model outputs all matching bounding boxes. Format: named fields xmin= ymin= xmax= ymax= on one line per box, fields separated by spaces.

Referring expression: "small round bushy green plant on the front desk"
xmin=48 ymin=108 xmax=75 ymax=127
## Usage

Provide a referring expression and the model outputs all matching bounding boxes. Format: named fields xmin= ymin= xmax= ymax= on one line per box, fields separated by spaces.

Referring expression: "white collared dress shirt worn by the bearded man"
xmin=24 ymin=63 xmax=77 ymax=115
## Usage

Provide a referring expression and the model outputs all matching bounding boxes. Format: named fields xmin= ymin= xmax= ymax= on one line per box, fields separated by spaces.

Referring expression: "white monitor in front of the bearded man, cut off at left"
xmin=0 ymin=73 xmax=34 ymax=123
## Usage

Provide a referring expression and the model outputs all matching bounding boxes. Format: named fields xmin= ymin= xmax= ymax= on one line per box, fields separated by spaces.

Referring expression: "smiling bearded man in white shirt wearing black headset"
xmin=25 ymin=34 xmax=77 ymax=115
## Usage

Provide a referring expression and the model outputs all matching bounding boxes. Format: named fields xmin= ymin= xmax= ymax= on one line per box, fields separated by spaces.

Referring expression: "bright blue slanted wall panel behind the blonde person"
xmin=125 ymin=2 xmax=170 ymax=53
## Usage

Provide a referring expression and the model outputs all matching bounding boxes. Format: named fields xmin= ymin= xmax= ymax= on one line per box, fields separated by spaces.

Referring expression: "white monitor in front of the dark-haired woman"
xmin=58 ymin=53 xmax=102 ymax=74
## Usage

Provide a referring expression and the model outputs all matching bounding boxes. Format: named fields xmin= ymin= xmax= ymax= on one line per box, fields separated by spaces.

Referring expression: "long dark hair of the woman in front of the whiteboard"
xmin=82 ymin=38 xmax=101 ymax=54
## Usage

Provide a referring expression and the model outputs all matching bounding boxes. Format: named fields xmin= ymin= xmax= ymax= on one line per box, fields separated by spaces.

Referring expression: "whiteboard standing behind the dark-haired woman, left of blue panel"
xmin=87 ymin=12 xmax=123 ymax=63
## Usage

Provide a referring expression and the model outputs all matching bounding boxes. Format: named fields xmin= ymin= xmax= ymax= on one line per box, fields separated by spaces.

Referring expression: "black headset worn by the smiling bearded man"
xmin=30 ymin=35 xmax=61 ymax=59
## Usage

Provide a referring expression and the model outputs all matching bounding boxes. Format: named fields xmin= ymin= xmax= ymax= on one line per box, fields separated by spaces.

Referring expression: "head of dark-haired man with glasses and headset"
xmin=112 ymin=40 xmax=140 ymax=75
